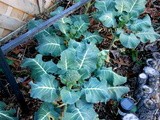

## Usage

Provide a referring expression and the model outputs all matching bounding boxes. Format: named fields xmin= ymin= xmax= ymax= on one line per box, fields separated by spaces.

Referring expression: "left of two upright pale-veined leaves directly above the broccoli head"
xmin=57 ymin=48 xmax=78 ymax=71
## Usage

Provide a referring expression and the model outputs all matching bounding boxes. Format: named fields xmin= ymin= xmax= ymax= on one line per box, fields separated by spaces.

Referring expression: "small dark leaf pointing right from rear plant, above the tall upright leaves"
xmin=83 ymin=32 xmax=103 ymax=44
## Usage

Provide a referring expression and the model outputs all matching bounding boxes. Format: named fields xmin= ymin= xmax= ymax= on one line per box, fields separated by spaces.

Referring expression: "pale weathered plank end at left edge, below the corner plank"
xmin=0 ymin=14 xmax=25 ymax=30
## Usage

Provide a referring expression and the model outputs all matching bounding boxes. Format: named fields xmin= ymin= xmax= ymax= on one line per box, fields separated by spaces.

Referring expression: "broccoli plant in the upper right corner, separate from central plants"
xmin=94 ymin=0 xmax=160 ymax=48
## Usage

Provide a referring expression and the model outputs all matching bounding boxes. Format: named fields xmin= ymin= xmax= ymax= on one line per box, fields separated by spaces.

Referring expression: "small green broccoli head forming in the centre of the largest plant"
xmin=60 ymin=70 xmax=81 ymax=86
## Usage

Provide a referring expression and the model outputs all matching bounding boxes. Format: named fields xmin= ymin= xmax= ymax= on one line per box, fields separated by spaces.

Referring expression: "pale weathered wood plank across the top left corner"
xmin=0 ymin=0 xmax=39 ymax=15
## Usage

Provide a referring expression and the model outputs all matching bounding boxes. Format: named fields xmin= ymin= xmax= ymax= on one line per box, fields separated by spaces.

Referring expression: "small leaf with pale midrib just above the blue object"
xmin=106 ymin=86 xmax=129 ymax=102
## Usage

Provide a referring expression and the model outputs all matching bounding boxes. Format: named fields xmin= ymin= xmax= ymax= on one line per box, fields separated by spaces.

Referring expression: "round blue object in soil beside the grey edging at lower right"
xmin=120 ymin=98 xmax=135 ymax=113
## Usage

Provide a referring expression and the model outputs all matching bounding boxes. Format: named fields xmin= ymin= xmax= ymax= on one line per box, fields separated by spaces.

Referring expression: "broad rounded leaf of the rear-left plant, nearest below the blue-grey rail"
xmin=37 ymin=35 xmax=66 ymax=56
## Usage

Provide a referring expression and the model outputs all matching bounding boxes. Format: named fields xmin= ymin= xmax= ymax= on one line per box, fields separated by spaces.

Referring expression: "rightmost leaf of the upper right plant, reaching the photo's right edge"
xmin=136 ymin=28 xmax=160 ymax=43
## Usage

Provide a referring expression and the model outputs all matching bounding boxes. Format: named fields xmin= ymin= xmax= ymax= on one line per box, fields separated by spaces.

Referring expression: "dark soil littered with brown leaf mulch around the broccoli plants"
xmin=0 ymin=0 xmax=160 ymax=120
